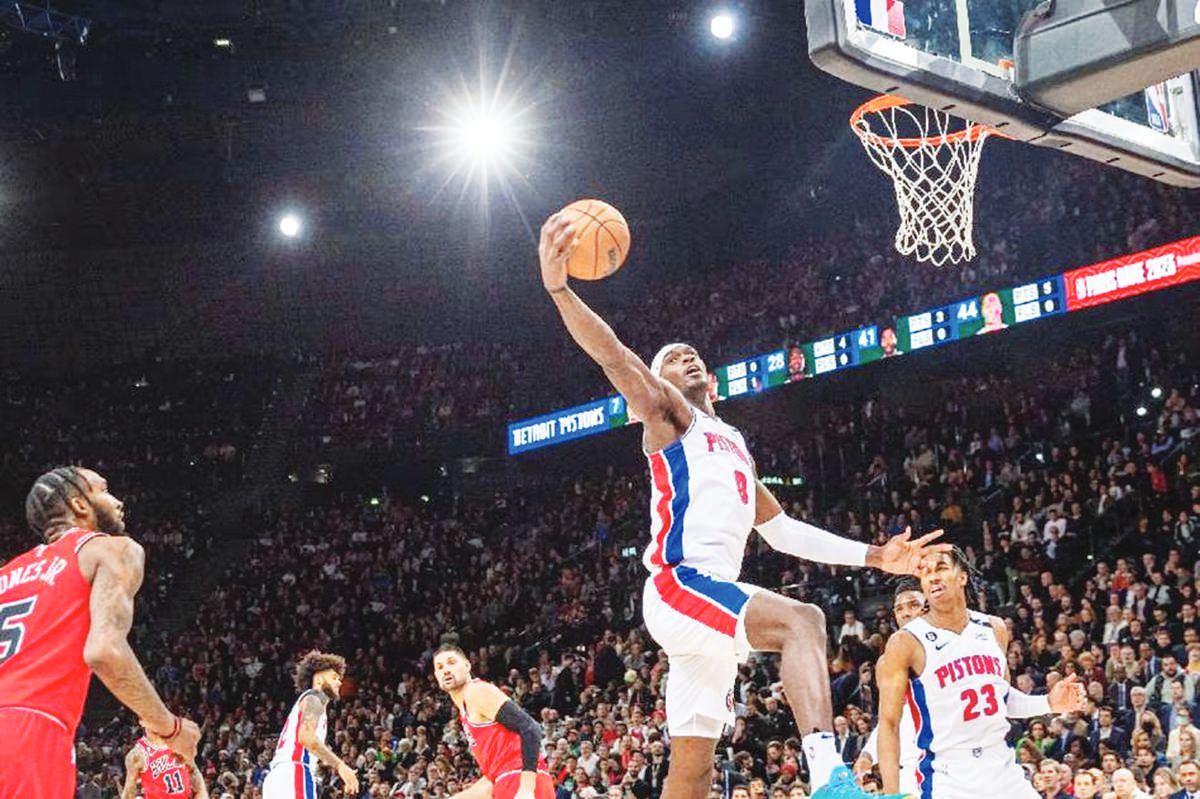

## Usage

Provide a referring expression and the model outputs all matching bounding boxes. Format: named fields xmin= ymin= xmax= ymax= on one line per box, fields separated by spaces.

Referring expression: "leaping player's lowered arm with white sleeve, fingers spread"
xmin=754 ymin=480 xmax=952 ymax=575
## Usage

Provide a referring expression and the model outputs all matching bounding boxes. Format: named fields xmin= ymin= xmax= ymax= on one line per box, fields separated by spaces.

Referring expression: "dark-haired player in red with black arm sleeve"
xmin=433 ymin=644 xmax=554 ymax=799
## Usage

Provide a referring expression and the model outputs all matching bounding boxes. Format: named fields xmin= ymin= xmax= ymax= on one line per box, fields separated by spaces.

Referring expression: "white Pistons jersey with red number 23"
xmin=904 ymin=611 xmax=1009 ymax=753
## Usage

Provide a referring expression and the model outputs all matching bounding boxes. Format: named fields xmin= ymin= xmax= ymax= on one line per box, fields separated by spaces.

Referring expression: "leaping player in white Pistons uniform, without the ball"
xmin=539 ymin=209 xmax=948 ymax=799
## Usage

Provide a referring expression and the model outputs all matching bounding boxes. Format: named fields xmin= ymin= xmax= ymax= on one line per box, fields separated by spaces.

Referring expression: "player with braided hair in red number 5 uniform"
xmin=0 ymin=467 xmax=200 ymax=799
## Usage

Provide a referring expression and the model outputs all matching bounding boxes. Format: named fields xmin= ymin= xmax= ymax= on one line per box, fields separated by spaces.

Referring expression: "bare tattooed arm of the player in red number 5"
xmin=79 ymin=536 xmax=200 ymax=762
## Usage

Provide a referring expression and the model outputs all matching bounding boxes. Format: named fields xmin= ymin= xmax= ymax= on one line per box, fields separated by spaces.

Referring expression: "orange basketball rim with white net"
xmin=850 ymin=95 xmax=998 ymax=266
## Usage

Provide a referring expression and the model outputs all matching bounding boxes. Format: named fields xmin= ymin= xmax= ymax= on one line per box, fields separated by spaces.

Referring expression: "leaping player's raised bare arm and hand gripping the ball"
xmin=538 ymin=215 xmax=691 ymax=440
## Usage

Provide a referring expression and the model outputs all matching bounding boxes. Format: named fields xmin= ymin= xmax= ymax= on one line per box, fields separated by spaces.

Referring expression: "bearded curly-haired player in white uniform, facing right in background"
xmin=263 ymin=649 xmax=359 ymax=799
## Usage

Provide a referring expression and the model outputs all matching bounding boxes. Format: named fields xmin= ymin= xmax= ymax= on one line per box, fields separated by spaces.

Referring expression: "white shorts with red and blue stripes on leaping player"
xmin=642 ymin=565 xmax=762 ymax=739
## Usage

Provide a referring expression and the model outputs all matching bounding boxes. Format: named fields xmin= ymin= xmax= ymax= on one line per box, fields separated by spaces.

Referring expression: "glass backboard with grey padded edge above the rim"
xmin=805 ymin=0 xmax=1200 ymax=186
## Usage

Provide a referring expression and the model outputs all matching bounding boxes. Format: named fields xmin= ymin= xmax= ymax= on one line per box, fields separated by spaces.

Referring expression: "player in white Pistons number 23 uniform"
xmin=876 ymin=549 xmax=1084 ymax=799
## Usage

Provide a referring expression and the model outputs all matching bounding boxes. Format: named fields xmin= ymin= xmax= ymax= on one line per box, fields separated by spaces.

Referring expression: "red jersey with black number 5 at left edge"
xmin=0 ymin=529 xmax=104 ymax=735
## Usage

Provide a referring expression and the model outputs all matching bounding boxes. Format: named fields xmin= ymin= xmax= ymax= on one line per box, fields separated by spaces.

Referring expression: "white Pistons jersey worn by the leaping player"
xmin=642 ymin=408 xmax=755 ymax=581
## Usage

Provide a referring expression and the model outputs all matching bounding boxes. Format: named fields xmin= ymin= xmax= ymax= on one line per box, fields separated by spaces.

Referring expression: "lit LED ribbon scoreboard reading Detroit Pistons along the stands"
xmin=508 ymin=236 xmax=1200 ymax=455
